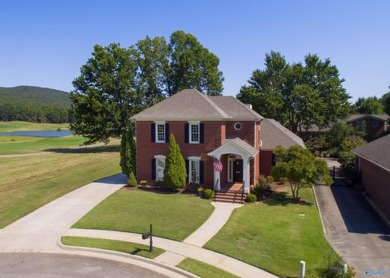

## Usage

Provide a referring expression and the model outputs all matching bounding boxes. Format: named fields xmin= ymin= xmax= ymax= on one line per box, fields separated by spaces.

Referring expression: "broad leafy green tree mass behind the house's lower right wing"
xmin=237 ymin=51 xmax=350 ymax=133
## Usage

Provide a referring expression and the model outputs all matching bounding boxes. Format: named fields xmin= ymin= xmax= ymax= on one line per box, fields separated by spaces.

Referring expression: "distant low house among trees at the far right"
xmin=347 ymin=114 xmax=390 ymax=138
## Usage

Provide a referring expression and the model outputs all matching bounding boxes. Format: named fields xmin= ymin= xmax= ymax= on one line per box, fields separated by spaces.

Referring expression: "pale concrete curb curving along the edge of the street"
xmin=57 ymin=238 xmax=199 ymax=278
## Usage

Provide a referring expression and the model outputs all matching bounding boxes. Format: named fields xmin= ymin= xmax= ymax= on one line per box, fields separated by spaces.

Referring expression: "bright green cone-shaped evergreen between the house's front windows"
xmin=164 ymin=134 xmax=187 ymax=190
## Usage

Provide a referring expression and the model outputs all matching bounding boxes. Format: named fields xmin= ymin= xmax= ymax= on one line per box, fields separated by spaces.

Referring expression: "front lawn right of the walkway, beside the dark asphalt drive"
xmin=205 ymin=189 xmax=338 ymax=277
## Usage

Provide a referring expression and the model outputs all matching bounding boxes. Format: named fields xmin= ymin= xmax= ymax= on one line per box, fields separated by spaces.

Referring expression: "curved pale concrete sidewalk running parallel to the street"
xmin=63 ymin=229 xmax=277 ymax=278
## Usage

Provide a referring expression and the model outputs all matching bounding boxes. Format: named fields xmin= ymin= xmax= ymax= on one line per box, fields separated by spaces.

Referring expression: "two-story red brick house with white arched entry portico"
xmin=132 ymin=89 xmax=263 ymax=193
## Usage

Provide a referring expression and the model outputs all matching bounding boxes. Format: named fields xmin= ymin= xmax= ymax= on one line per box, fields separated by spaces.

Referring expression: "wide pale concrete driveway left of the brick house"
xmin=0 ymin=175 xmax=126 ymax=252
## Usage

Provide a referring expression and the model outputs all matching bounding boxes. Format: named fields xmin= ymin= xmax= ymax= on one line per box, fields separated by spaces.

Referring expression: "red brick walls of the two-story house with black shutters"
xmin=136 ymin=121 xmax=260 ymax=187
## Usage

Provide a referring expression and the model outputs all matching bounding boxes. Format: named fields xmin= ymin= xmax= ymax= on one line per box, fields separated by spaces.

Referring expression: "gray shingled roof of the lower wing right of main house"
xmin=260 ymin=119 xmax=306 ymax=150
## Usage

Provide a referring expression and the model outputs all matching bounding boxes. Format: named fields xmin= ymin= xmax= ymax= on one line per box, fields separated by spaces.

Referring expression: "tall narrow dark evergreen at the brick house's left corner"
xmin=120 ymin=127 xmax=137 ymax=177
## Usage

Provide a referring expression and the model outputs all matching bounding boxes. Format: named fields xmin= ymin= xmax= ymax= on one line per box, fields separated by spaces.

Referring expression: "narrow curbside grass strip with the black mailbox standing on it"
xmin=61 ymin=236 xmax=165 ymax=259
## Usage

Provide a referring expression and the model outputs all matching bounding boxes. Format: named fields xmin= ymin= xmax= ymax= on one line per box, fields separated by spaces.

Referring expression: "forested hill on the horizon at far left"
xmin=0 ymin=86 xmax=71 ymax=123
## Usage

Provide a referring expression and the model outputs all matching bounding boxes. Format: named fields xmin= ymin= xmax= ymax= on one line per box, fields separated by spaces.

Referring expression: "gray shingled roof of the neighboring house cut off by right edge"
xmin=352 ymin=134 xmax=390 ymax=171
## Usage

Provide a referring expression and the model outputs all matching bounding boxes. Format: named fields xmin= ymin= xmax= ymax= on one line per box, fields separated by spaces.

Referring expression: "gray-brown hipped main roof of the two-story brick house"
xmin=131 ymin=89 xmax=263 ymax=121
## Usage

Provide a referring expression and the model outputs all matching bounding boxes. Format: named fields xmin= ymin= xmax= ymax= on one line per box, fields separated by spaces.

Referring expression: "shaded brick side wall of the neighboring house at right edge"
xmin=360 ymin=158 xmax=390 ymax=219
